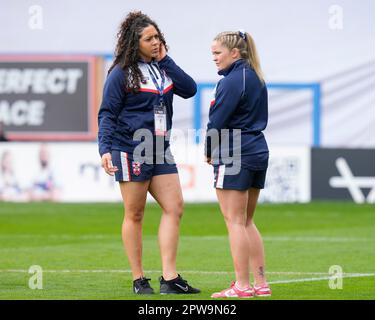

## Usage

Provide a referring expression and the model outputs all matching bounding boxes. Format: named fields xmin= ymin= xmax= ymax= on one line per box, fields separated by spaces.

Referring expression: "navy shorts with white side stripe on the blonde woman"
xmin=214 ymin=165 xmax=267 ymax=190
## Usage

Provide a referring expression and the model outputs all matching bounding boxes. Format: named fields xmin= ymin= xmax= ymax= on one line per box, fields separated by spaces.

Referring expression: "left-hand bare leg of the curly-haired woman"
xmin=120 ymin=181 xmax=150 ymax=280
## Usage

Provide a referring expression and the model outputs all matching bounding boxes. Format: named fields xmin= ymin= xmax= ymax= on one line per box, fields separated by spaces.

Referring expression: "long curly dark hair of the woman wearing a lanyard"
xmin=108 ymin=11 xmax=167 ymax=93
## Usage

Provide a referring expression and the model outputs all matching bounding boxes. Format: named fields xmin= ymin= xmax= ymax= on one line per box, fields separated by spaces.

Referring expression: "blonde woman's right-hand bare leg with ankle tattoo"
xmin=246 ymin=188 xmax=266 ymax=286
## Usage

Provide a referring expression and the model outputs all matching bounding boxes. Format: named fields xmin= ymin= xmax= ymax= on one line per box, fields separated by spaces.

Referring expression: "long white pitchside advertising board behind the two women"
xmin=0 ymin=142 xmax=310 ymax=202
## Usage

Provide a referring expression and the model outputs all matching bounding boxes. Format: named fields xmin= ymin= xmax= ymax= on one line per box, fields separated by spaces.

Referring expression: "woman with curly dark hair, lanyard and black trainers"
xmin=98 ymin=12 xmax=200 ymax=294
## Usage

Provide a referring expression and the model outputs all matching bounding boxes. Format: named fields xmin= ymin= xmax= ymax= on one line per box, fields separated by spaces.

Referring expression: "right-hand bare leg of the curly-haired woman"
xmin=149 ymin=174 xmax=183 ymax=280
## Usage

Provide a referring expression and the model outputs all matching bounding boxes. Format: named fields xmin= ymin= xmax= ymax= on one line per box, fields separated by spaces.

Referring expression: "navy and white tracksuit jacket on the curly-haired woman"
xmin=98 ymin=56 xmax=197 ymax=156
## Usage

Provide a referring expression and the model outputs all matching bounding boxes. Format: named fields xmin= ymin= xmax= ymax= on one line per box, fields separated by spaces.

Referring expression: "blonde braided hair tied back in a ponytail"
xmin=214 ymin=31 xmax=264 ymax=82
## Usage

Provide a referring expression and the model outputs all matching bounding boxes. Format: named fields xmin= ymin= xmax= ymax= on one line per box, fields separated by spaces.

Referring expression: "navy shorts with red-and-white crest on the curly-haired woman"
xmin=112 ymin=150 xmax=178 ymax=182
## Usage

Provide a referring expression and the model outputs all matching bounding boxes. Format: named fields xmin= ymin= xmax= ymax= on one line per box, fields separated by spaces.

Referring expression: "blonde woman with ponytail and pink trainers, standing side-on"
xmin=205 ymin=31 xmax=271 ymax=298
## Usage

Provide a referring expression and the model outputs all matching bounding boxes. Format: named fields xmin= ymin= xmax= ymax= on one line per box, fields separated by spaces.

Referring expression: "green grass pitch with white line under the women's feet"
xmin=0 ymin=203 xmax=375 ymax=299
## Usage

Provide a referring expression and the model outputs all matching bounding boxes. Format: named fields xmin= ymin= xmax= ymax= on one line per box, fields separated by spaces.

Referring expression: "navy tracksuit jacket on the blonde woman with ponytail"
xmin=205 ymin=59 xmax=268 ymax=170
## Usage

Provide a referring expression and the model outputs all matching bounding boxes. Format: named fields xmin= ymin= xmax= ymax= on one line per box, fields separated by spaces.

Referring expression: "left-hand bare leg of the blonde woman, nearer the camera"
xmin=216 ymin=189 xmax=250 ymax=288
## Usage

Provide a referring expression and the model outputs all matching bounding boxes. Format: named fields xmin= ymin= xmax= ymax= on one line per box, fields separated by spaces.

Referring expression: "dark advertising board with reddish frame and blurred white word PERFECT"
xmin=0 ymin=55 xmax=98 ymax=141
